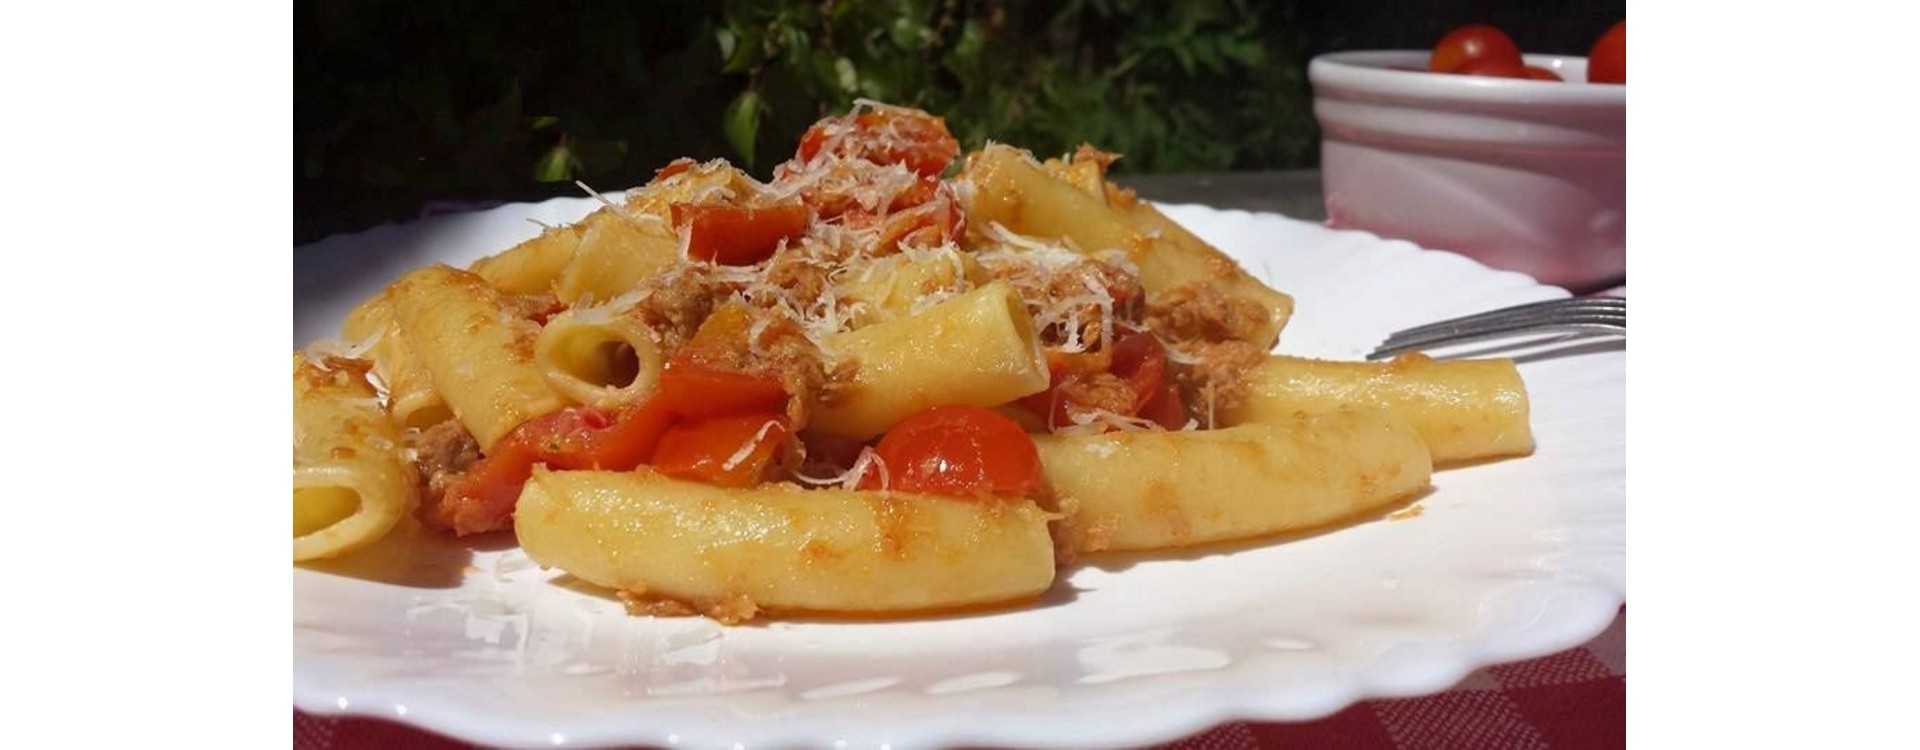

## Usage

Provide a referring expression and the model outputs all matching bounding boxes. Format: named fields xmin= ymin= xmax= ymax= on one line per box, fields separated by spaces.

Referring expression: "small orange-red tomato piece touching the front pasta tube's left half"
xmin=653 ymin=412 xmax=789 ymax=487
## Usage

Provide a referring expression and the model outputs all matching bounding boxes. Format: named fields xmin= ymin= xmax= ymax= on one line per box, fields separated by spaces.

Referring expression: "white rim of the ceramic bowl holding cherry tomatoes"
xmin=1308 ymin=50 xmax=1626 ymax=109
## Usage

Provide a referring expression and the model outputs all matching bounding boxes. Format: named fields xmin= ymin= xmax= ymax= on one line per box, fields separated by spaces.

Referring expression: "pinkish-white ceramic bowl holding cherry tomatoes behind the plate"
xmin=1308 ymin=50 xmax=1626 ymax=288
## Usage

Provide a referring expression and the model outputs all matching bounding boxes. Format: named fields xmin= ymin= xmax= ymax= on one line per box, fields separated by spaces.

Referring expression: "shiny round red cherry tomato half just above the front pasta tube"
xmin=860 ymin=407 xmax=1041 ymax=497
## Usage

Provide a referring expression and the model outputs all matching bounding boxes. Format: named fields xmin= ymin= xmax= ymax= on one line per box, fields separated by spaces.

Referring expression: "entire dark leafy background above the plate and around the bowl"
xmin=294 ymin=0 xmax=1624 ymax=244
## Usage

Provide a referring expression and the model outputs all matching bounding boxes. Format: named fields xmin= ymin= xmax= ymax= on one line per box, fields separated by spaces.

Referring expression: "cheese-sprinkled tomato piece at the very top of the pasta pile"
xmin=797 ymin=109 xmax=960 ymax=175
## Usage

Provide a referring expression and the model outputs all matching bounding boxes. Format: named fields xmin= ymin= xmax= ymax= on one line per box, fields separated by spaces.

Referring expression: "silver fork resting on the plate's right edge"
xmin=1367 ymin=297 xmax=1626 ymax=359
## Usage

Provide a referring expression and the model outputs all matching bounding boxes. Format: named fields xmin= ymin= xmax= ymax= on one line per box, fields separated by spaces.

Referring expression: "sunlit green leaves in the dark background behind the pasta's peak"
xmin=714 ymin=0 xmax=1317 ymax=171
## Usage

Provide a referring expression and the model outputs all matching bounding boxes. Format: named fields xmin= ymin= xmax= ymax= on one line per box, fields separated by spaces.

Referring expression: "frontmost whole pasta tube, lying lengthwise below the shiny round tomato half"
xmin=515 ymin=466 xmax=1054 ymax=621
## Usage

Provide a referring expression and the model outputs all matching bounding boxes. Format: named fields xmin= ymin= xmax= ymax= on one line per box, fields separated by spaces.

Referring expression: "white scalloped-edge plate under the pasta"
xmin=294 ymin=199 xmax=1626 ymax=748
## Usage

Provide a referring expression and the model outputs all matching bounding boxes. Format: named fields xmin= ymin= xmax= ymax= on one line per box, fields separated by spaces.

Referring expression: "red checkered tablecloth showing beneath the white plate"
xmin=294 ymin=606 xmax=1626 ymax=750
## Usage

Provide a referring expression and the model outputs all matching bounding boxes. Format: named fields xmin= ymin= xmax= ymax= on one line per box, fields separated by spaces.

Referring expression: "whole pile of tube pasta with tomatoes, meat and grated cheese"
xmin=294 ymin=102 xmax=1532 ymax=623
